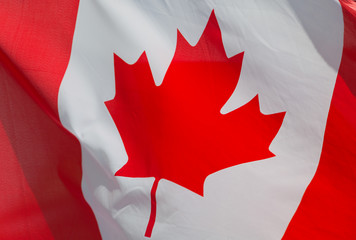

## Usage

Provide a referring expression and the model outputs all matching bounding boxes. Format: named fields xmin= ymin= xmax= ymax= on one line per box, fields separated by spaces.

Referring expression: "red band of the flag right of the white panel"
xmin=283 ymin=0 xmax=356 ymax=240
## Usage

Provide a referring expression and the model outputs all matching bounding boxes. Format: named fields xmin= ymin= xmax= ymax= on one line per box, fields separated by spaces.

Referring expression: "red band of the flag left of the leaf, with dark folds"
xmin=0 ymin=0 xmax=101 ymax=240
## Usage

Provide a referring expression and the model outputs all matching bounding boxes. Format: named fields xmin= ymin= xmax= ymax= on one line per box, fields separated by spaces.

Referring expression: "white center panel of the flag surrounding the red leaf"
xmin=58 ymin=0 xmax=343 ymax=240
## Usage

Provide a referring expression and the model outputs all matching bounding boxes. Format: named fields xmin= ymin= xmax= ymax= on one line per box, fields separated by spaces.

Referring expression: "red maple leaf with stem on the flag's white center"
xmin=105 ymin=11 xmax=284 ymax=237
